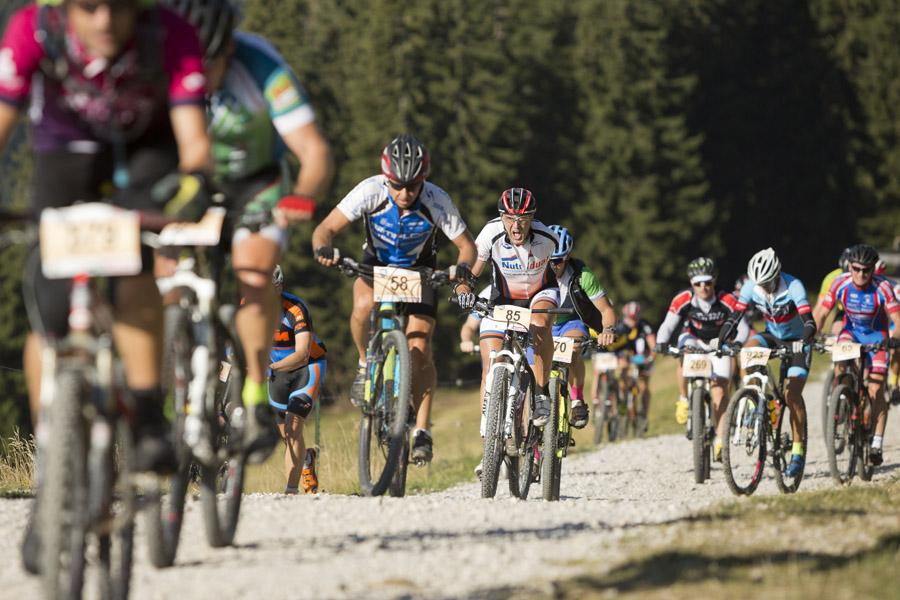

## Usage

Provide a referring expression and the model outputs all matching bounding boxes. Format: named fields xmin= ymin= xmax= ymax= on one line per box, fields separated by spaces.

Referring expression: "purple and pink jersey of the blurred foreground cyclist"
xmin=0 ymin=5 xmax=206 ymax=152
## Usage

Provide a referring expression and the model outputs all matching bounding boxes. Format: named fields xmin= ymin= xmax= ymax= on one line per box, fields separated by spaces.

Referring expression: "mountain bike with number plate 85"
xmin=464 ymin=299 xmax=571 ymax=499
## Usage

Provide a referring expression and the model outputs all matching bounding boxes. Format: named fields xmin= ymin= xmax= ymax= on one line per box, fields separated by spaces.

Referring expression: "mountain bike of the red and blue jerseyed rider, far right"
xmin=815 ymin=339 xmax=900 ymax=485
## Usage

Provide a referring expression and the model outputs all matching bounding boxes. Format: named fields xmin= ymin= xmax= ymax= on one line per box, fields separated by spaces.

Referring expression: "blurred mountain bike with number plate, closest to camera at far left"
xmin=18 ymin=202 xmax=176 ymax=598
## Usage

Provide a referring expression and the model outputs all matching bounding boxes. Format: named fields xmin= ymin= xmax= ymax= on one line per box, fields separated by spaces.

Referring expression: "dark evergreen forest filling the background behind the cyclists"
xmin=0 ymin=0 xmax=900 ymax=433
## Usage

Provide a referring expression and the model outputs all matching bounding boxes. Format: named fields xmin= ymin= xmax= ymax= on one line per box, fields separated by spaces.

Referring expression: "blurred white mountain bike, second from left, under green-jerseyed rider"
xmin=146 ymin=208 xmax=246 ymax=556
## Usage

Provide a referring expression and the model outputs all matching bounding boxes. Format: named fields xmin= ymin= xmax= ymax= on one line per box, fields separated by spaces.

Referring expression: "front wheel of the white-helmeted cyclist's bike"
xmin=722 ymin=387 xmax=768 ymax=496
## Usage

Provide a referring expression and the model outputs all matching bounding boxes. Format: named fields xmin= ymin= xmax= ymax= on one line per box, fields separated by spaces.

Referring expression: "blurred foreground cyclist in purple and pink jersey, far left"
xmin=0 ymin=0 xmax=210 ymax=570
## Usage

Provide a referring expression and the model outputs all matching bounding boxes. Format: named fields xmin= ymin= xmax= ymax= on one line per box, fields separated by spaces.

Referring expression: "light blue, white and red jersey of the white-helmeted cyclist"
xmin=735 ymin=273 xmax=812 ymax=340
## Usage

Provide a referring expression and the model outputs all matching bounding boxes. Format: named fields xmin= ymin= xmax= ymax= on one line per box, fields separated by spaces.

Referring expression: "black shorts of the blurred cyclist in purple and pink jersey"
xmin=24 ymin=127 xmax=178 ymax=337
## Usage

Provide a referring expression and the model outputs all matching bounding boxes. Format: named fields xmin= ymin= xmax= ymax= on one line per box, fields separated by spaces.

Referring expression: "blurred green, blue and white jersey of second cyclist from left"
xmin=209 ymin=31 xmax=315 ymax=181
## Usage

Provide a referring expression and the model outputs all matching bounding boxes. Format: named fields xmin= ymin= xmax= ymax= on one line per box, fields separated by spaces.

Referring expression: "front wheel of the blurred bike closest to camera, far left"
xmin=37 ymin=371 xmax=88 ymax=598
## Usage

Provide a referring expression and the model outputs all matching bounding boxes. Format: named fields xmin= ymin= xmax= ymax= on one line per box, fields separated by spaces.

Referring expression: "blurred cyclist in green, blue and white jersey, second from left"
xmin=164 ymin=0 xmax=331 ymax=463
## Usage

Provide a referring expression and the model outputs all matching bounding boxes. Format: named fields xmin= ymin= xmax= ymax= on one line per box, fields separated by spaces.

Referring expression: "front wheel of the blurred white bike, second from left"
xmin=144 ymin=306 xmax=194 ymax=568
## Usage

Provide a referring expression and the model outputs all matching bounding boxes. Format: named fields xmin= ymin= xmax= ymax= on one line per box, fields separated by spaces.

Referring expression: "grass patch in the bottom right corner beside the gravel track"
xmin=532 ymin=478 xmax=900 ymax=600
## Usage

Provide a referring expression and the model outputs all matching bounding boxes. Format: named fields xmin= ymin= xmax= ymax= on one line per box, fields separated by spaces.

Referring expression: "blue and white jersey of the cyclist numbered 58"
xmin=337 ymin=175 xmax=466 ymax=267
